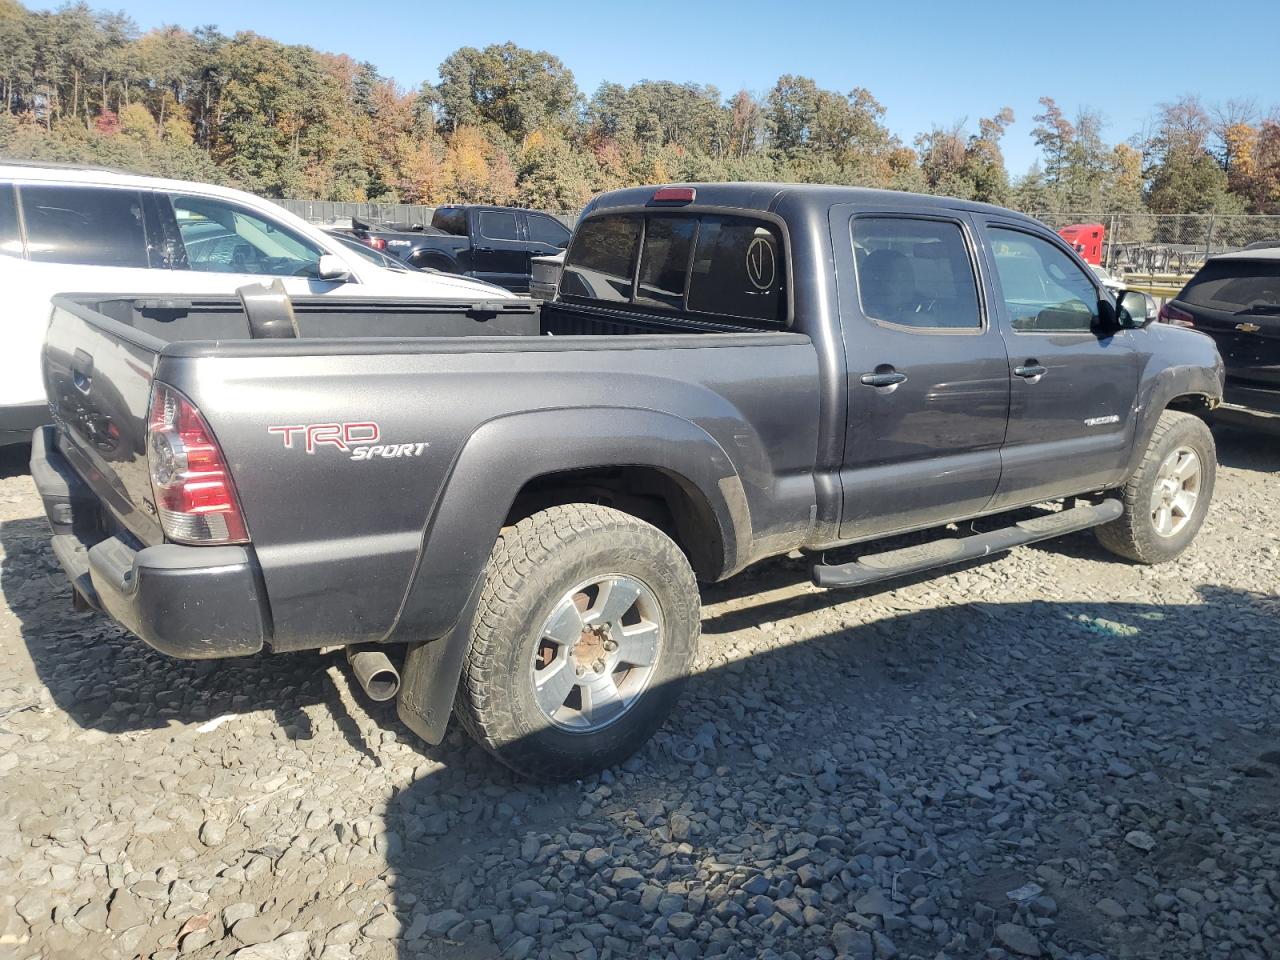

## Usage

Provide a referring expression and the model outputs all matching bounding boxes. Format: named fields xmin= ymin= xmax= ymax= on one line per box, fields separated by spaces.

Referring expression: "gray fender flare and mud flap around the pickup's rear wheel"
xmin=387 ymin=407 xmax=751 ymax=744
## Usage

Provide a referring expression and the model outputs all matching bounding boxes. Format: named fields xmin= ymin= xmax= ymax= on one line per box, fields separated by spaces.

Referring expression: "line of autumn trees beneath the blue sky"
xmin=0 ymin=0 xmax=1280 ymax=214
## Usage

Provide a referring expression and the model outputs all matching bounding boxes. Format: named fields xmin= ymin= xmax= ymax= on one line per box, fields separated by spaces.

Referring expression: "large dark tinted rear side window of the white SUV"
xmin=19 ymin=186 xmax=150 ymax=268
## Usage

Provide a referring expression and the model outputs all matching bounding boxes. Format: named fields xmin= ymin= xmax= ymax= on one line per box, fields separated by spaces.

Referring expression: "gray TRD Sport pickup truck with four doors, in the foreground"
xmin=32 ymin=184 xmax=1222 ymax=778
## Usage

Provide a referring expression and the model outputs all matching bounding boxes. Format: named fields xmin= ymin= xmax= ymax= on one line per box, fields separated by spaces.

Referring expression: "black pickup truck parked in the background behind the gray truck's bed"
xmin=351 ymin=205 xmax=570 ymax=293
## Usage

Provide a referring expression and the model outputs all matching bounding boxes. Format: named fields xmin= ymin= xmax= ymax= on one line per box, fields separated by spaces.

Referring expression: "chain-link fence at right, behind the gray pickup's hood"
xmin=1032 ymin=212 xmax=1280 ymax=276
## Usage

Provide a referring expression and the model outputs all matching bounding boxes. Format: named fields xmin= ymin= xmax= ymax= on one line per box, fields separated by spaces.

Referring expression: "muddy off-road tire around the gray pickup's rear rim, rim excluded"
xmin=454 ymin=503 xmax=700 ymax=781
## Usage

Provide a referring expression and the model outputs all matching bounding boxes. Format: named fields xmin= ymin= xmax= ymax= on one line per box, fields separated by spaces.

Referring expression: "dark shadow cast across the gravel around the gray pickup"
xmin=0 ymin=506 xmax=1280 ymax=960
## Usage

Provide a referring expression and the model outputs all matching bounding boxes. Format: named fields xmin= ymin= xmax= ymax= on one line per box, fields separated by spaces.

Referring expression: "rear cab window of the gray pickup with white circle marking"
xmin=559 ymin=212 xmax=787 ymax=328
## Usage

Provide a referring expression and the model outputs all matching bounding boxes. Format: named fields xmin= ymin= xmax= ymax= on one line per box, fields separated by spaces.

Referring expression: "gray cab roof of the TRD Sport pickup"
xmin=584 ymin=183 xmax=1039 ymax=224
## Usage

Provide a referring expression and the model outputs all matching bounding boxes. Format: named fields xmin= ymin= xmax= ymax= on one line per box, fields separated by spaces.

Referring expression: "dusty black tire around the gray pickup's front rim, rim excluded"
xmin=1096 ymin=410 xmax=1217 ymax=563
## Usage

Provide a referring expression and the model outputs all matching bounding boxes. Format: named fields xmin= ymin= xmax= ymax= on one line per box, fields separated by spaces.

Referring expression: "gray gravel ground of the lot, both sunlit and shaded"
xmin=0 ymin=433 xmax=1280 ymax=960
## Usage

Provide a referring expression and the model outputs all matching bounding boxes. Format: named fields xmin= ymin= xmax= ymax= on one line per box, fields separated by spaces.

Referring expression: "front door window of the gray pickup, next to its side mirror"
xmin=991 ymin=227 xmax=1098 ymax=333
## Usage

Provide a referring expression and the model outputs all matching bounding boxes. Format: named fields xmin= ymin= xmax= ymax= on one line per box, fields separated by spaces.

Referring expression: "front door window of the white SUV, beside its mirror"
xmin=172 ymin=196 xmax=321 ymax=278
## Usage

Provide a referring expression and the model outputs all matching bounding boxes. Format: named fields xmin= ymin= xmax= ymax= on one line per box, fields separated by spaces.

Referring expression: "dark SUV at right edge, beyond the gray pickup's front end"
xmin=1160 ymin=247 xmax=1280 ymax=422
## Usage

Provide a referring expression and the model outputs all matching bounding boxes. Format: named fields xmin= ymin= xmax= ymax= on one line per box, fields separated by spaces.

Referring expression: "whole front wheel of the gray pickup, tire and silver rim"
xmin=1097 ymin=410 xmax=1217 ymax=563
